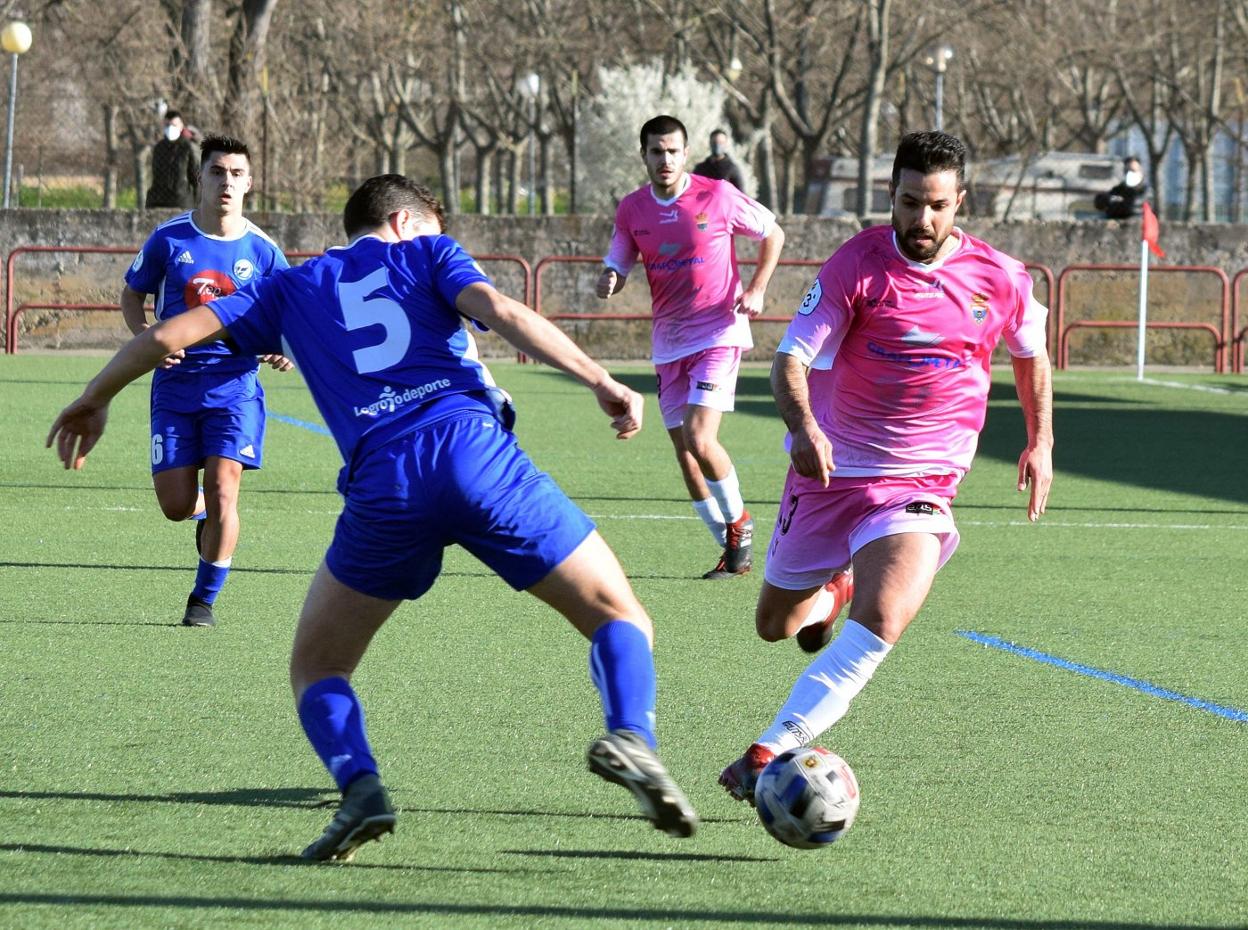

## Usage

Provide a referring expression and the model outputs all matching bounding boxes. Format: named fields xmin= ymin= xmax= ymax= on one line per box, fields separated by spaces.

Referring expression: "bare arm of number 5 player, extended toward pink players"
xmin=456 ymin=283 xmax=641 ymax=439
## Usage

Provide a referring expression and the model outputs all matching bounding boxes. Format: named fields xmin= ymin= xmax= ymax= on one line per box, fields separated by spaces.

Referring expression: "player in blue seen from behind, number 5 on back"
xmin=47 ymin=175 xmax=698 ymax=859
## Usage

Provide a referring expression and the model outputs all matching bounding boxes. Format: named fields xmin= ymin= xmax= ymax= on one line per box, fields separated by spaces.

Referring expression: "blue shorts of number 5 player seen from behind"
xmin=324 ymin=412 xmax=594 ymax=600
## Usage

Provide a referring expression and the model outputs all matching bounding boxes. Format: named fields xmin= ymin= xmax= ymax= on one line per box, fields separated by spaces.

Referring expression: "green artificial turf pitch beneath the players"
xmin=0 ymin=356 xmax=1248 ymax=930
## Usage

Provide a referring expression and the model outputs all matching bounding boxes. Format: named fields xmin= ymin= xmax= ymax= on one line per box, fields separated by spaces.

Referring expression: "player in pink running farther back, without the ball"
xmin=598 ymin=116 xmax=784 ymax=578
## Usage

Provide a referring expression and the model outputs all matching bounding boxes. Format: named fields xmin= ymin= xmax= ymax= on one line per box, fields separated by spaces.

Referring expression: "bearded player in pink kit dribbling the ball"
xmin=719 ymin=131 xmax=1053 ymax=803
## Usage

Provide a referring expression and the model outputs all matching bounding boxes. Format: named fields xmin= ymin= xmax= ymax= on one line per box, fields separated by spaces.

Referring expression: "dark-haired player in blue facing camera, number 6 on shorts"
xmin=121 ymin=136 xmax=292 ymax=627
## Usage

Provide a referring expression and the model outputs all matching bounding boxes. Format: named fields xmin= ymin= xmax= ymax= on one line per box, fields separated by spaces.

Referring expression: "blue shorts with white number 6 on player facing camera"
xmin=151 ymin=396 xmax=265 ymax=474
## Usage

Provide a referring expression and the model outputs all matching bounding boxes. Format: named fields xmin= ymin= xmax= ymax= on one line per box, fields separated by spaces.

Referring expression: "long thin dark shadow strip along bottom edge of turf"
xmin=0 ymin=888 xmax=1228 ymax=930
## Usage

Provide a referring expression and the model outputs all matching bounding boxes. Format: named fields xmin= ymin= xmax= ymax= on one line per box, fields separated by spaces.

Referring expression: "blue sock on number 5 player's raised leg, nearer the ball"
xmin=589 ymin=620 xmax=658 ymax=749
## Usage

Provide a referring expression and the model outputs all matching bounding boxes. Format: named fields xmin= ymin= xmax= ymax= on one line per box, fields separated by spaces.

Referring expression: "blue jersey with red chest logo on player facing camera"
xmin=126 ymin=213 xmax=290 ymax=409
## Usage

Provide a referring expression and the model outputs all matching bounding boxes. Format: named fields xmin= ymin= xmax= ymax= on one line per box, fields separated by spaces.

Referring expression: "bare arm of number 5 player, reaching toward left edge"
xmin=47 ymin=307 xmax=225 ymax=468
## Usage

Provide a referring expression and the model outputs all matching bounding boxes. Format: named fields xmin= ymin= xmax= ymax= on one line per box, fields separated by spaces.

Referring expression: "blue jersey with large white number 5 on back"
xmin=212 ymin=236 xmax=494 ymax=463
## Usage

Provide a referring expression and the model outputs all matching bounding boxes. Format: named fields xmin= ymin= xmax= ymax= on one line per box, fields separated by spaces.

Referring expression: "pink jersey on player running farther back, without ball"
xmin=603 ymin=175 xmax=776 ymax=365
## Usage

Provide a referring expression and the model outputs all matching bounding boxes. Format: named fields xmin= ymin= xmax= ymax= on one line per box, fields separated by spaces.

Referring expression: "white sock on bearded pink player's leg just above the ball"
xmin=758 ymin=619 xmax=892 ymax=753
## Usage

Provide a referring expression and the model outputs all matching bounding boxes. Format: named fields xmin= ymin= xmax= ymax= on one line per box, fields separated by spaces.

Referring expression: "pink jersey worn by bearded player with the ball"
xmin=778 ymin=226 xmax=1048 ymax=477
